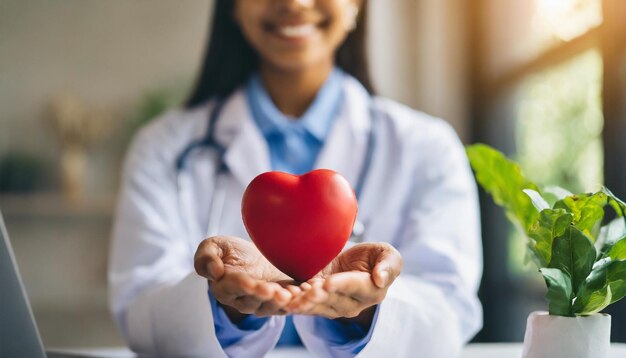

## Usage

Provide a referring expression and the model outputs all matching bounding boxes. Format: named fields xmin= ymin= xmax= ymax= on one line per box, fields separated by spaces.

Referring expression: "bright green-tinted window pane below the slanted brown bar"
xmin=515 ymin=49 xmax=603 ymax=199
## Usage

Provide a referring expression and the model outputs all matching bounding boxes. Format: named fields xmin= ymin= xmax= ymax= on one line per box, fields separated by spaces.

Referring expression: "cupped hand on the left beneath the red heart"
xmin=194 ymin=236 xmax=300 ymax=323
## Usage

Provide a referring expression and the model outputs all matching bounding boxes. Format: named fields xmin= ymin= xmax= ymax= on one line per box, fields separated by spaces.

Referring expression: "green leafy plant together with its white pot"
xmin=467 ymin=144 xmax=626 ymax=358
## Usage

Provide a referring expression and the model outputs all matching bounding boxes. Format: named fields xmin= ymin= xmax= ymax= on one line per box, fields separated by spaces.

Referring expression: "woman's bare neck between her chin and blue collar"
xmin=260 ymin=62 xmax=333 ymax=117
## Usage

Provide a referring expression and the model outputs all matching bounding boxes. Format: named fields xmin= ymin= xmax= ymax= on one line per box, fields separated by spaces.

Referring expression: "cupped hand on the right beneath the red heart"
xmin=286 ymin=243 xmax=402 ymax=328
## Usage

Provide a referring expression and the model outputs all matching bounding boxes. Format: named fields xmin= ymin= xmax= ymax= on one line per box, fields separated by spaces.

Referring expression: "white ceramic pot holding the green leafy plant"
xmin=522 ymin=311 xmax=611 ymax=358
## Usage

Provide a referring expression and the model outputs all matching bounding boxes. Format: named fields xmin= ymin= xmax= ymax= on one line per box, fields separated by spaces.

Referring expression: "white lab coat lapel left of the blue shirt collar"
xmin=216 ymin=90 xmax=270 ymax=187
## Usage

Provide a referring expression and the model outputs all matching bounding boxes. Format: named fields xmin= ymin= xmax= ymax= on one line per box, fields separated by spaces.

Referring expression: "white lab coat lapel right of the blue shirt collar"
xmin=315 ymin=76 xmax=370 ymax=188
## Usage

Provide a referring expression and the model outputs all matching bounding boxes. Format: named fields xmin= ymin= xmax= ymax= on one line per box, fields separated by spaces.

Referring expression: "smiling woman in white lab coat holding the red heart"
xmin=109 ymin=0 xmax=482 ymax=358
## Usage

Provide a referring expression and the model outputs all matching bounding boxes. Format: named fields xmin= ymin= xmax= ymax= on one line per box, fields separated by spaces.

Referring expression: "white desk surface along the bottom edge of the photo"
xmin=50 ymin=343 xmax=626 ymax=358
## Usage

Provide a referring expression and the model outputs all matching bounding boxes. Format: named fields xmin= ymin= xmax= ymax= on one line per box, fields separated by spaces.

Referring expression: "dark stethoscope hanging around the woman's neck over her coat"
xmin=176 ymin=97 xmax=386 ymax=243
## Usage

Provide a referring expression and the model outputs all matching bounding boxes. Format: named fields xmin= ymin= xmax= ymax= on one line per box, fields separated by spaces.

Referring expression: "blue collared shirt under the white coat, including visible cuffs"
xmin=209 ymin=69 xmax=378 ymax=355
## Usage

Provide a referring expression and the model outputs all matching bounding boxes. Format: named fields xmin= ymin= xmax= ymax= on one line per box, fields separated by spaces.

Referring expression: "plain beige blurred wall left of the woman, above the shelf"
xmin=0 ymin=0 xmax=210 ymax=193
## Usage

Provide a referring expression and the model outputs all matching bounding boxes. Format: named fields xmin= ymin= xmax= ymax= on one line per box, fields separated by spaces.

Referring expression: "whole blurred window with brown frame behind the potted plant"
xmin=471 ymin=0 xmax=626 ymax=341
